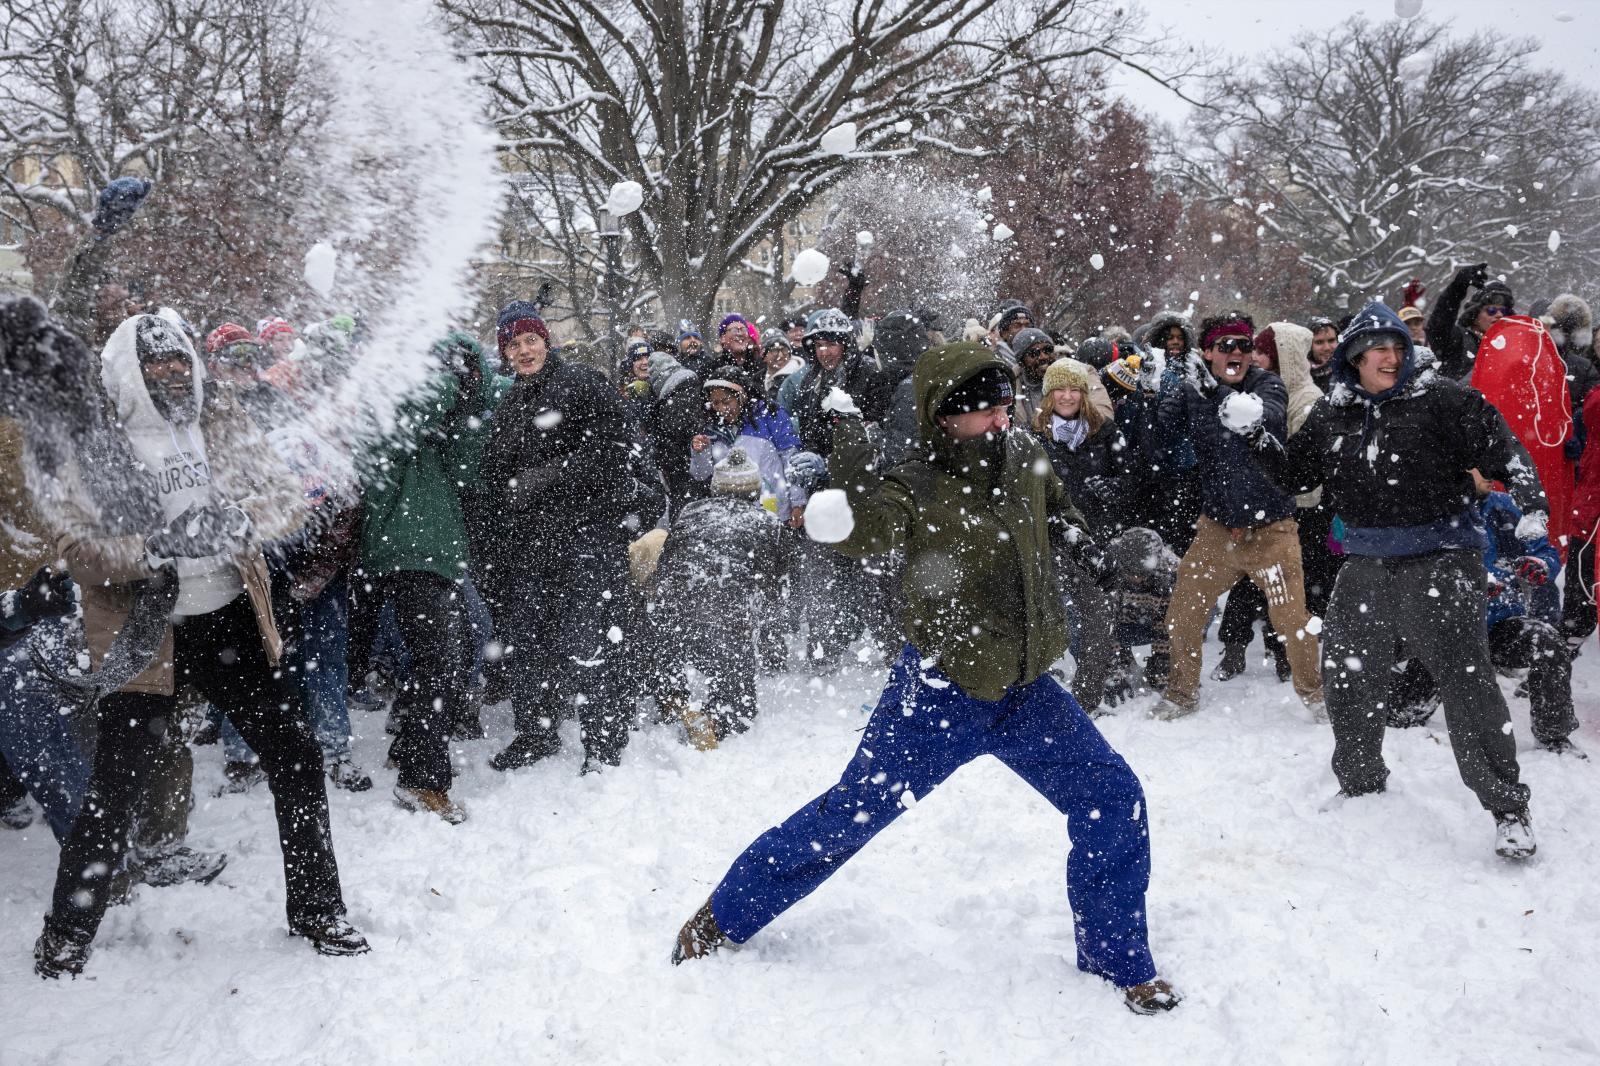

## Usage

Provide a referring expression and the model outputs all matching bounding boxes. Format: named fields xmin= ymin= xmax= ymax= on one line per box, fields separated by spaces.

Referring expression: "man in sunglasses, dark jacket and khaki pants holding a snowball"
xmin=1154 ymin=312 xmax=1323 ymax=720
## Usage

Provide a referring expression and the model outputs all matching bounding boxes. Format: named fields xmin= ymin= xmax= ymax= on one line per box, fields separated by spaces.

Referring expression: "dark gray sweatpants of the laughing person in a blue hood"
xmin=1322 ymin=549 xmax=1528 ymax=812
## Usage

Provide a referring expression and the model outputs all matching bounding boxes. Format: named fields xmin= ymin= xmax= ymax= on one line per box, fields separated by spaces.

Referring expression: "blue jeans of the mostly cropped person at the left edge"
xmin=0 ymin=619 xmax=90 ymax=842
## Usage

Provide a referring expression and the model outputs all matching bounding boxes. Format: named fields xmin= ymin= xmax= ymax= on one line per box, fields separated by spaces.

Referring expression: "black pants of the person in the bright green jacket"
xmin=373 ymin=570 xmax=472 ymax=792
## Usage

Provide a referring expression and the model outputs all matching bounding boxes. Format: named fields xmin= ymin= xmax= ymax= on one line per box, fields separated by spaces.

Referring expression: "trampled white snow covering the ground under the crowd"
xmin=0 ymin=624 xmax=1600 ymax=1066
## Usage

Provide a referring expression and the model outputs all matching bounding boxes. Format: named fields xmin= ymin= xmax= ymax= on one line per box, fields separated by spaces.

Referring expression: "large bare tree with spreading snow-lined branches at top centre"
xmin=440 ymin=0 xmax=1190 ymax=328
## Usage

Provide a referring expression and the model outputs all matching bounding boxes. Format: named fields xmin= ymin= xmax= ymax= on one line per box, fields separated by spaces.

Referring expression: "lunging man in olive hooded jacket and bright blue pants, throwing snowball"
xmin=672 ymin=343 xmax=1179 ymax=1013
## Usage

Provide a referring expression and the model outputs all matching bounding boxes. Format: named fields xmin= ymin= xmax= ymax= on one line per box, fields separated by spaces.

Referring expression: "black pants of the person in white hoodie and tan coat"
xmin=50 ymin=595 xmax=344 ymax=940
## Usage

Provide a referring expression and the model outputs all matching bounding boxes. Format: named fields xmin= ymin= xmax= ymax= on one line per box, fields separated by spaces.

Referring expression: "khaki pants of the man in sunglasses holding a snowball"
xmin=1166 ymin=515 xmax=1322 ymax=707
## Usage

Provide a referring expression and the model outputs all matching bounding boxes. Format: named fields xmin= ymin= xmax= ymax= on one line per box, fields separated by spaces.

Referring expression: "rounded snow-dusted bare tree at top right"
xmin=1187 ymin=18 xmax=1600 ymax=298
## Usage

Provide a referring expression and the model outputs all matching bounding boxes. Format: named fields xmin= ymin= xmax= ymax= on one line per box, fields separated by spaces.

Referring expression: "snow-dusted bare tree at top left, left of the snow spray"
xmin=0 ymin=0 xmax=323 ymax=320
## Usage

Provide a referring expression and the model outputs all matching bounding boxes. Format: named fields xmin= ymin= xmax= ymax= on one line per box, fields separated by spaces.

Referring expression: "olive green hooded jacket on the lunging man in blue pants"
xmin=827 ymin=344 xmax=1083 ymax=699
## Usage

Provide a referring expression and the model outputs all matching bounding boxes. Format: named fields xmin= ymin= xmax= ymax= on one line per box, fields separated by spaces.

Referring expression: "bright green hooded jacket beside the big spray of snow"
xmin=362 ymin=333 xmax=510 ymax=581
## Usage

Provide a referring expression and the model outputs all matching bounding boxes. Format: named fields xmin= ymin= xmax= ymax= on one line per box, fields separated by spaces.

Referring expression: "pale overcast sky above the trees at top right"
xmin=1117 ymin=0 xmax=1600 ymax=123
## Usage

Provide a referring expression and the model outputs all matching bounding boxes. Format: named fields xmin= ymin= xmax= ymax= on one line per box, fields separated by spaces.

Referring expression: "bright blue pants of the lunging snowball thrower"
xmin=710 ymin=645 xmax=1155 ymax=988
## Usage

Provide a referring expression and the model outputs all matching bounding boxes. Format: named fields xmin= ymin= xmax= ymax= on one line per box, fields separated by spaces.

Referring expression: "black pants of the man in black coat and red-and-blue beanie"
xmin=491 ymin=544 xmax=642 ymax=765
